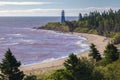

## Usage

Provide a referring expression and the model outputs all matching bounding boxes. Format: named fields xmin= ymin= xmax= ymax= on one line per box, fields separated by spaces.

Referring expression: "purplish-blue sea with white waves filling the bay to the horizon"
xmin=0 ymin=17 xmax=89 ymax=65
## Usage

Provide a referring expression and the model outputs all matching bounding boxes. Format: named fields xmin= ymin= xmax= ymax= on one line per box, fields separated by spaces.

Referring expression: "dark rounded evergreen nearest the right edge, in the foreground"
xmin=104 ymin=43 xmax=119 ymax=63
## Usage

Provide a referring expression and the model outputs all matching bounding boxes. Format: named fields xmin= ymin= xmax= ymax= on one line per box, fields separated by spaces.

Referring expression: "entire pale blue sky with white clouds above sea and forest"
xmin=0 ymin=0 xmax=120 ymax=16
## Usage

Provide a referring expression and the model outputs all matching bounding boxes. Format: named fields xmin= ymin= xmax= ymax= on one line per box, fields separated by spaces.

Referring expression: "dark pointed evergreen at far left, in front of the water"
xmin=0 ymin=49 xmax=24 ymax=80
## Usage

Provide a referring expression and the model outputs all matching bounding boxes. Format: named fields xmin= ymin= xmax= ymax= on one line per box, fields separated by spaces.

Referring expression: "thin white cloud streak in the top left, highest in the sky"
xmin=0 ymin=1 xmax=53 ymax=6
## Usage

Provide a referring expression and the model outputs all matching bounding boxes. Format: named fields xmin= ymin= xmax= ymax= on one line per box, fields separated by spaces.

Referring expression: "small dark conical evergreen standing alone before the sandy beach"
xmin=89 ymin=44 xmax=101 ymax=61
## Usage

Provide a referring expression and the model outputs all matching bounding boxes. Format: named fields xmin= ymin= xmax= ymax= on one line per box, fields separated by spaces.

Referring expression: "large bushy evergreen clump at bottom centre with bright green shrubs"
xmin=47 ymin=54 xmax=104 ymax=80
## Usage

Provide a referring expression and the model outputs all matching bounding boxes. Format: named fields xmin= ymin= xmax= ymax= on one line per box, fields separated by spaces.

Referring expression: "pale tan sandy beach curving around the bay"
xmin=20 ymin=33 xmax=109 ymax=74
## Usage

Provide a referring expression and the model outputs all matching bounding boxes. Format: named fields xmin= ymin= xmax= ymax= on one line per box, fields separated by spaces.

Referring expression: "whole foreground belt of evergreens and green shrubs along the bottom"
xmin=0 ymin=44 xmax=120 ymax=80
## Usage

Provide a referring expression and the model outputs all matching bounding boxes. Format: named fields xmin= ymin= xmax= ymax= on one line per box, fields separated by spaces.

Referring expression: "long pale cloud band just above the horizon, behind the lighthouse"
xmin=0 ymin=7 xmax=120 ymax=16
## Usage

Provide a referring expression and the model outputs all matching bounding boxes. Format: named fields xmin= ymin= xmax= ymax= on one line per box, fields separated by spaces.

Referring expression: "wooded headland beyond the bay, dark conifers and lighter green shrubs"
xmin=39 ymin=9 xmax=120 ymax=44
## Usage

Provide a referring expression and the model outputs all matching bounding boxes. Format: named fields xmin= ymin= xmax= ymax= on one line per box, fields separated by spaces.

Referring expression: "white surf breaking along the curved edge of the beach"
xmin=21 ymin=30 xmax=89 ymax=67
